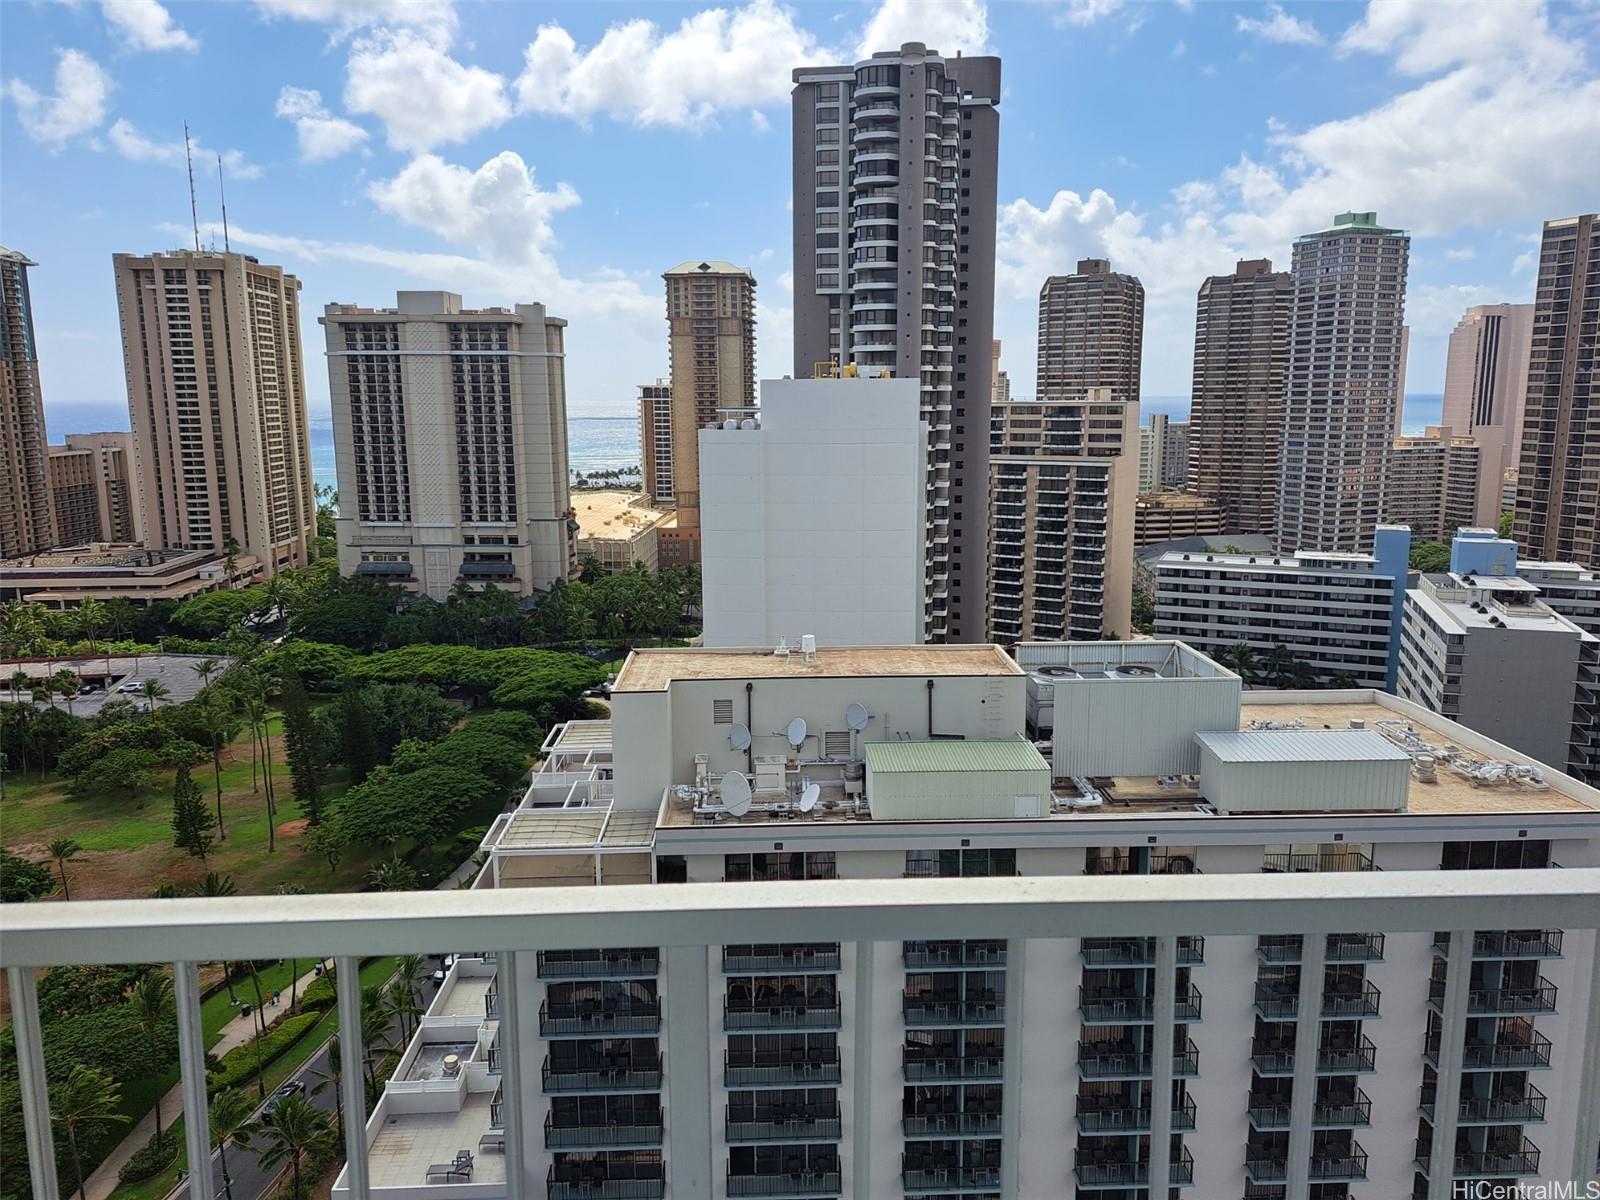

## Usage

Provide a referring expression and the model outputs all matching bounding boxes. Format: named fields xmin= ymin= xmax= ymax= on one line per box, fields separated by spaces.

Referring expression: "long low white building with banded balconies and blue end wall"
xmin=1155 ymin=526 xmax=1411 ymax=690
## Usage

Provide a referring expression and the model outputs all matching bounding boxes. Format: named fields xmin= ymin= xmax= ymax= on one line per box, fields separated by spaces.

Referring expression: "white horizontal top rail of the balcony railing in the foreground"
xmin=0 ymin=867 xmax=1600 ymax=966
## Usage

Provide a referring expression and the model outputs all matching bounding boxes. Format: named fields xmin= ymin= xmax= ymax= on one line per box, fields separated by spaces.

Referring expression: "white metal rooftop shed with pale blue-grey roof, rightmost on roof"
xmin=1195 ymin=730 xmax=1411 ymax=813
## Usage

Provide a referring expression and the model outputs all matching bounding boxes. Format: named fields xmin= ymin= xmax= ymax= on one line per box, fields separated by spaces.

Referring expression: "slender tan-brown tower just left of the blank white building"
xmin=661 ymin=259 xmax=755 ymax=563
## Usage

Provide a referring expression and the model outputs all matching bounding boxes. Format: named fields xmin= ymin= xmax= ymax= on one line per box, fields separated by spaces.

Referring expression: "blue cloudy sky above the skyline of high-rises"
xmin=0 ymin=0 xmax=1600 ymax=437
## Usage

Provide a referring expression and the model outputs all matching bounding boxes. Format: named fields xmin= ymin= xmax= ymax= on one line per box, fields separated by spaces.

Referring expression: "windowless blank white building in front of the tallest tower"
xmin=699 ymin=379 xmax=928 ymax=653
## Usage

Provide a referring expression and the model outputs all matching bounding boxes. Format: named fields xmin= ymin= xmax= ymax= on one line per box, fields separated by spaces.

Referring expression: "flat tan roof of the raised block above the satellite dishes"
xmin=611 ymin=646 xmax=1022 ymax=693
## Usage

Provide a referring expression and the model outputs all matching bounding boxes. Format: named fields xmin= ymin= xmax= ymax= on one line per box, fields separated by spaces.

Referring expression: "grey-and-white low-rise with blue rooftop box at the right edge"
xmin=1398 ymin=530 xmax=1600 ymax=782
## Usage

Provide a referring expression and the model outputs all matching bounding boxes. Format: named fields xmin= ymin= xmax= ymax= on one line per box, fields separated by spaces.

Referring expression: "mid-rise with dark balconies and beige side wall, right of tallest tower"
xmin=989 ymin=387 xmax=1139 ymax=645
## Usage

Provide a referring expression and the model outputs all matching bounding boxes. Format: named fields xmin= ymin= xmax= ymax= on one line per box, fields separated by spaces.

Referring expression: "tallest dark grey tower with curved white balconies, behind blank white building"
xmin=794 ymin=42 xmax=1000 ymax=642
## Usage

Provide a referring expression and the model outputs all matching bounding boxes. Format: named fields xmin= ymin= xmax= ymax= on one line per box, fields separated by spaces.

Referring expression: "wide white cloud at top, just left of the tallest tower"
xmin=517 ymin=0 xmax=825 ymax=128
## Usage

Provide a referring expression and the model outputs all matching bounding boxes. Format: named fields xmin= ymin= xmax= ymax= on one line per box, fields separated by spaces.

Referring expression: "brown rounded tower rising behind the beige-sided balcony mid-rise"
xmin=1035 ymin=258 xmax=1144 ymax=403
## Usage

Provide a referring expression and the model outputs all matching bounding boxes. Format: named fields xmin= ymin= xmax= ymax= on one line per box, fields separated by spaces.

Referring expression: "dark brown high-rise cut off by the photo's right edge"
xmin=1514 ymin=213 xmax=1600 ymax=563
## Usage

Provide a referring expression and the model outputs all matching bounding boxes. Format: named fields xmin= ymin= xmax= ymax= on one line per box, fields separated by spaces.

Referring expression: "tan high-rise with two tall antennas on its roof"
xmin=112 ymin=250 xmax=317 ymax=578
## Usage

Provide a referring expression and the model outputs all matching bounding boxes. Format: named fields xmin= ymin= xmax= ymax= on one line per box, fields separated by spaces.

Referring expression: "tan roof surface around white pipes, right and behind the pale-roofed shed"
xmin=1238 ymin=691 xmax=1594 ymax=813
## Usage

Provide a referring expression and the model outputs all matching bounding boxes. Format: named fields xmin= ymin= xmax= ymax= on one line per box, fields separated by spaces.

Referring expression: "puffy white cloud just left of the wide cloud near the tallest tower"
xmin=344 ymin=30 xmax=510 ymax=152
